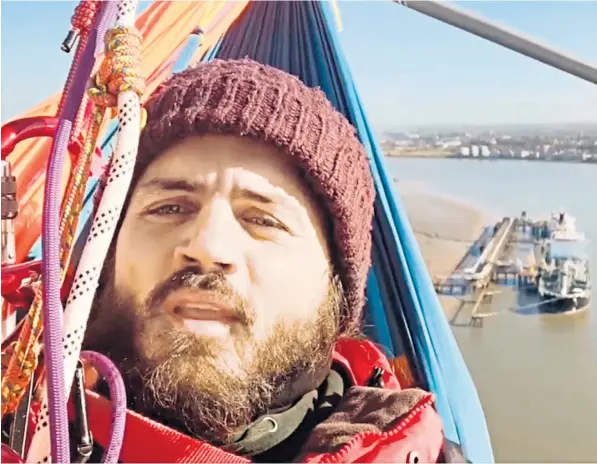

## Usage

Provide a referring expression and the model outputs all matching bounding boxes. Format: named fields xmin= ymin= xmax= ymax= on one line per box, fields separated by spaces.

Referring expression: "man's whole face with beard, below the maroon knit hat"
xmin=88 ymin=135 xmax=340 ymax=440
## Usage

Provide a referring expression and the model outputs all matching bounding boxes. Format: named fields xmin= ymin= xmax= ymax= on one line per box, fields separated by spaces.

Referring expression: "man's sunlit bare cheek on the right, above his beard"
xmin=247 ymin=239 xmax=329 ymax=329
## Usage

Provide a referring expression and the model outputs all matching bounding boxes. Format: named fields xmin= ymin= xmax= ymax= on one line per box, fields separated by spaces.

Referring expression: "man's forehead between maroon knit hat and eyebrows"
xmin=140 ymin=134 xmax=314 ymax=203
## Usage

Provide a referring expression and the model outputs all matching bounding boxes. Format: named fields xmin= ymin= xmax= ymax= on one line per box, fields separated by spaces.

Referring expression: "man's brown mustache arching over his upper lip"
xmin=146 ymin=266 xmax=255 ymax=326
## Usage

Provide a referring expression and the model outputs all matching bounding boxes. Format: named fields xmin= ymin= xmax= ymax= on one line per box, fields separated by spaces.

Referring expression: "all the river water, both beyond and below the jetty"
xmin=388 ymin=158 xmax=597 ymax=462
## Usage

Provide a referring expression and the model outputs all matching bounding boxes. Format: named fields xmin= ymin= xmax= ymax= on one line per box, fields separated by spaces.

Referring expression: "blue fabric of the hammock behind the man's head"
xmin=32 ymin=1 xmax=494 ymax=463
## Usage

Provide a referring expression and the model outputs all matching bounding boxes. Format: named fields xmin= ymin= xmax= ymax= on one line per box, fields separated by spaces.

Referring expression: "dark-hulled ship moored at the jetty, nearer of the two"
xmin=537 ymin=240 xmax=591 ymax=312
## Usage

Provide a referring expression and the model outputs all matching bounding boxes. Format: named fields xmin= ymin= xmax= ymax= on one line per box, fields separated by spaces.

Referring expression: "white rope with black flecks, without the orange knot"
xmin=27 ymin=0 xmax=141 ymax=463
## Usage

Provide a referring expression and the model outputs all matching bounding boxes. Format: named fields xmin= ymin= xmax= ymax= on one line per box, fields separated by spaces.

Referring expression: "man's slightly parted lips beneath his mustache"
xmin=164 ymin=289 xmax=239 ymax=323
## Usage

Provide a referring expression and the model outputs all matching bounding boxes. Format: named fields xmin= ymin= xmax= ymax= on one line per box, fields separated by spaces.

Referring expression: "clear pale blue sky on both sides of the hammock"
xmin=1 ymin=0 xmax=597 ymax=130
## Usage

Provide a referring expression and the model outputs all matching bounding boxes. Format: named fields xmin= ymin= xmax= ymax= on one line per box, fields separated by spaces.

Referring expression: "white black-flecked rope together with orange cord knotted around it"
xmin=27 ymin=0 xmax=144 ymax=462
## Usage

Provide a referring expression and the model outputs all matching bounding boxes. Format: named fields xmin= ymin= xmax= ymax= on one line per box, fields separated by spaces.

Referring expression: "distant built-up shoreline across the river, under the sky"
xmin=381 ymin=125 xmax=597 ymax=163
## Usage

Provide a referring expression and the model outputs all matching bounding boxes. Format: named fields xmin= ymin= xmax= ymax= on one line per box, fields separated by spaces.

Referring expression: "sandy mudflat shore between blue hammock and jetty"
xmin=397 ymin=182 xmax=497 ymax=318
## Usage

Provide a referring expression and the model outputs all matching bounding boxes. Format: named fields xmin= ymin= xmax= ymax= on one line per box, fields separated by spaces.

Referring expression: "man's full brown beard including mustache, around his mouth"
xmin=84 ymin=268 xmax=342 ymax=445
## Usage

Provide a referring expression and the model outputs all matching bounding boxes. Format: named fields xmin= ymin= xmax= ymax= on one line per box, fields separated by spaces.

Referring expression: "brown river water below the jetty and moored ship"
xmin=453 ymin=289 xmax=597 ymax=462
